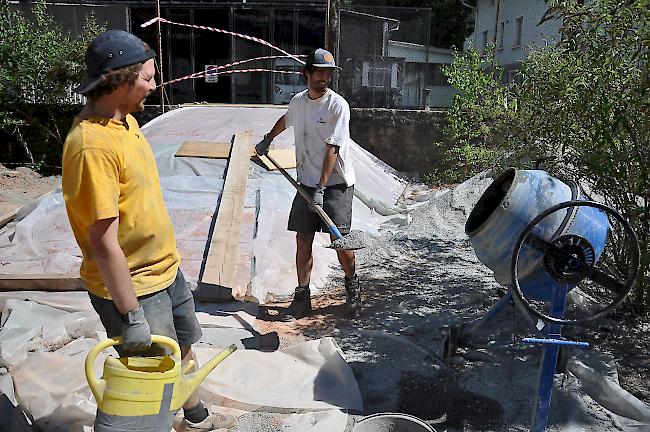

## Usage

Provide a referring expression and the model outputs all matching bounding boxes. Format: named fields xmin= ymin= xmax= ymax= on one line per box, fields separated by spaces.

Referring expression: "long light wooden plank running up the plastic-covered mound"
xmin=201 ymin=131 xmax=253 ymax=290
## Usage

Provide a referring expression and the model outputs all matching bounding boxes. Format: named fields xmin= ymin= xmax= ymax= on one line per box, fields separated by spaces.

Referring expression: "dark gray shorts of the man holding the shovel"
xmin=287 ymin=183 xmax=354 ymax=235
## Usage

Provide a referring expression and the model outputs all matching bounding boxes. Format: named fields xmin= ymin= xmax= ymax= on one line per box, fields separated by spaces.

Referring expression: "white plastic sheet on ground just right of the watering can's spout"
xmin=196 ymin=337 xmax=363 ymax=410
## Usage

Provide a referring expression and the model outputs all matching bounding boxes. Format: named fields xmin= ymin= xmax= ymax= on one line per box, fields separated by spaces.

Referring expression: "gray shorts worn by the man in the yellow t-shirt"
xmin=88 ymin=269 xmax=202 ymax=357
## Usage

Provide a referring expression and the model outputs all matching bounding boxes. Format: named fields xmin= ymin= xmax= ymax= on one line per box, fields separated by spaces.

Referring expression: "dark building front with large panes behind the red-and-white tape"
xmin=13 ymin=0 xmax=325 ymax=104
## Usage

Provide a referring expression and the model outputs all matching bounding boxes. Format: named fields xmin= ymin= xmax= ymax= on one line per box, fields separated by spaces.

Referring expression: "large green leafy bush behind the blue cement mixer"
xmin=443 ymin=0 xmax=650 ymax=305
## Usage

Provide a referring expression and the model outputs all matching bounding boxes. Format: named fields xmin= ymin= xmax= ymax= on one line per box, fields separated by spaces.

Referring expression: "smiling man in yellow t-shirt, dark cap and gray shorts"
xmin=62 ymin=30 xmax=237 ymax=432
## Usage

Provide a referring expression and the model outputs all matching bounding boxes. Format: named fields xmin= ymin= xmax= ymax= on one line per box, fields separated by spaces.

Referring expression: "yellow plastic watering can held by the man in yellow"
xmin=86 ymin=335 xmax=237 ymax=416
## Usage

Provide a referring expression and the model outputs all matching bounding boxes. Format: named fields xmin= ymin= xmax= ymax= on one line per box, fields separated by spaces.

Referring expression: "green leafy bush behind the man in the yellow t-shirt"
xmin=0 ymin=0 xmax=103 ymax=172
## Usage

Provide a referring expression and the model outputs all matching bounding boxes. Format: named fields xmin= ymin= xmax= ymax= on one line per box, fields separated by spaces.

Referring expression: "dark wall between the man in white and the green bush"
xmin=350 ymin=108 xmax=446 ymax=177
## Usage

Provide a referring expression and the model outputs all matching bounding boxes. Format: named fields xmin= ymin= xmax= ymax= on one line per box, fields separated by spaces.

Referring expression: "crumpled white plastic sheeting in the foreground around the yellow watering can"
xmin=0 ymin=292 xmax=361 ymax=431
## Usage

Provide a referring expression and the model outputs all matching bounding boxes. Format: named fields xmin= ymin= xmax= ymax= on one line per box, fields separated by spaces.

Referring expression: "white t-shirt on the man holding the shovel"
xmin=285 ymin=89 xmax=356 ymax=187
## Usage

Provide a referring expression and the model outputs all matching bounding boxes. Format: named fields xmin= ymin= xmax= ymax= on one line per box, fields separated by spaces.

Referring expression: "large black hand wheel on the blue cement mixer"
xmin=510 ymin=200 xmax=640 ymax=325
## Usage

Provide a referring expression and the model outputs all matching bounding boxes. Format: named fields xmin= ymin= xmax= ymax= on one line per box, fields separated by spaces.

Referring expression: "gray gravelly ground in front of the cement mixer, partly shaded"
xmin=258 ymin=173 xmax=650 ymax=432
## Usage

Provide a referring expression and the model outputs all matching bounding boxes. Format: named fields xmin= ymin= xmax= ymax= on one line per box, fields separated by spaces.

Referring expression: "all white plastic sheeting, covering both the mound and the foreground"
xmin=0 ymin=106 xmax=406 ymax=432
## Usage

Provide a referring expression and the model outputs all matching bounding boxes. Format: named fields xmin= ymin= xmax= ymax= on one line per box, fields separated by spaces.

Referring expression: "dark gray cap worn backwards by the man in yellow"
xmin=74 ymin=30 xmax=156 ymax=94
